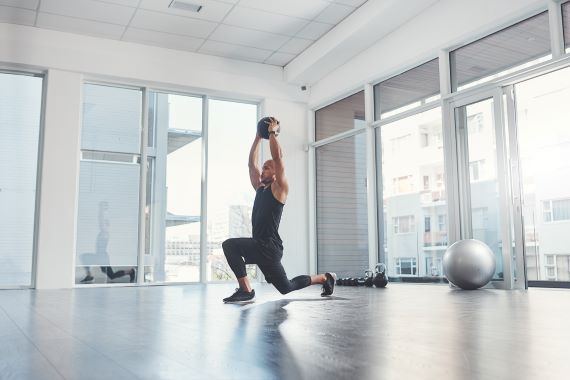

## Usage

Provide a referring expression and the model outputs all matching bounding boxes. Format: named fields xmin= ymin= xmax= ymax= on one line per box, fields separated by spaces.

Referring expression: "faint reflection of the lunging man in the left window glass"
xmin=81 ymin=201 xmax=135 ymax=283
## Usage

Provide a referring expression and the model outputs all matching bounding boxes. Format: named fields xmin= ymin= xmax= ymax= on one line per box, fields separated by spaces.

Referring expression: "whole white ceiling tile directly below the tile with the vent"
xmin=130 ymin=9 xmax=217 ymax=38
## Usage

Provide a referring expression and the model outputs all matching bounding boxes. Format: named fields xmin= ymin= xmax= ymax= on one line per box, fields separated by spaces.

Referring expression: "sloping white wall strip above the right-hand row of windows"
xmin=309 ymin=0 xmax=549 ymax=107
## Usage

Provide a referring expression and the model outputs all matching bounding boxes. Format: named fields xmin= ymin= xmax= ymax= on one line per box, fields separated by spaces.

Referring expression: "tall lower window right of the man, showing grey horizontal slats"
xmin=316 ymin=133 xmax=368 ymax=277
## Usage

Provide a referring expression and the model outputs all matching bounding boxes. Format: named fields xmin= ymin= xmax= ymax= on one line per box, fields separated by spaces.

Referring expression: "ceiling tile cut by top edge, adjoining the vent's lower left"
xmin=40 ymin=0 xmax=135 ymax=25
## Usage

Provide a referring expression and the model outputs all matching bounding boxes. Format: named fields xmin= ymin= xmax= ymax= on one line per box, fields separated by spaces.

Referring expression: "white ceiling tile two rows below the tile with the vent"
xmin=123 ymin=28 xmax=204 ymax=51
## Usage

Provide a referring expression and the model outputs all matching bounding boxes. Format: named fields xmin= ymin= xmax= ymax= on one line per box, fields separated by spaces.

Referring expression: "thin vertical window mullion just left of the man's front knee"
xmin=200 ymin=95 xmax=209 ymax=283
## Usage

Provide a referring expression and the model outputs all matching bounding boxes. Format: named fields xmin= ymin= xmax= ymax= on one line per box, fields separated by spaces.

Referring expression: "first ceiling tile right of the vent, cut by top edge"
xmin=239 ymin=0 xmax=329 ymax=20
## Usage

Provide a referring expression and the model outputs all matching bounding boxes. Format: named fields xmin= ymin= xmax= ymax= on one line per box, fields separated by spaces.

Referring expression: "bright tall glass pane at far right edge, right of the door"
xmin=515 ymin=68 xmax=570 ymax=281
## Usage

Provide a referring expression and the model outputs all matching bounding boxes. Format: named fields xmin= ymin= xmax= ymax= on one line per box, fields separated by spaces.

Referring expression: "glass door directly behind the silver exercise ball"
xmin=451 ymin=90 xmax=514 ymax=288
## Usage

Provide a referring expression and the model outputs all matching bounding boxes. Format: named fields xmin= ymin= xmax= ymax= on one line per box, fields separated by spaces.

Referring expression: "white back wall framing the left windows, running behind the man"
xmin=0 ymin=23 xmax=308 ymax=289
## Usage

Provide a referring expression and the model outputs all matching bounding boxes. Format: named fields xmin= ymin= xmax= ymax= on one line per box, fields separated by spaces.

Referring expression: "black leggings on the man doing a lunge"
xmin=222 ymin=238 xmax=311 ymax=294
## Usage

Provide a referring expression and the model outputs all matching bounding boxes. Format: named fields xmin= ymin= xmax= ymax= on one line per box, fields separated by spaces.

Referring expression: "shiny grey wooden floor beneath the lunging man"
xmin=0 ymin=284 xmax=570 ymax=380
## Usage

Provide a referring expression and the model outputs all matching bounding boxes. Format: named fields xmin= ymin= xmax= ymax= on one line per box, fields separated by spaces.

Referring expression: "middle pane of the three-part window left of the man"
xmin=144 ymin=91 xmax=202 ymax=282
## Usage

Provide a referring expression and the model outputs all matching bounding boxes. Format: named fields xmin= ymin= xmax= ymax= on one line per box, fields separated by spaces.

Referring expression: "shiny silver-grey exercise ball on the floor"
xmin=443 ymin=239 xmax=495 ymax=290
